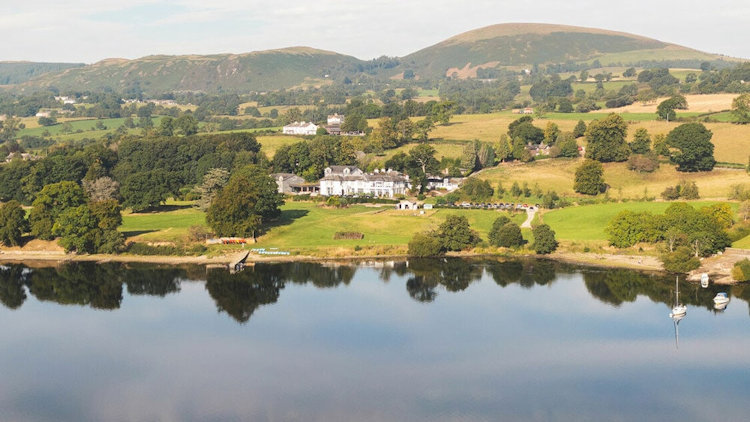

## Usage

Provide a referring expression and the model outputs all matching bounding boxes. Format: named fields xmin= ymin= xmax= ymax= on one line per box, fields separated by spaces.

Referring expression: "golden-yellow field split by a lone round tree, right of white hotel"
xmin=477 ymin=159 xmax=750 ymax=199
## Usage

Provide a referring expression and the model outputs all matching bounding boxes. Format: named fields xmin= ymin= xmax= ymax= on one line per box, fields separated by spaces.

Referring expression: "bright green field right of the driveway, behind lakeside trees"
xmin=543 ymin=201 xmax=736 ymax=241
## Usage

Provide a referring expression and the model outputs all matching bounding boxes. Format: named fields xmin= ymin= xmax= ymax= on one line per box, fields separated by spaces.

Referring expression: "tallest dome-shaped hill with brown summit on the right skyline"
xmin=400 ymin=23 xmax=731 ymax=78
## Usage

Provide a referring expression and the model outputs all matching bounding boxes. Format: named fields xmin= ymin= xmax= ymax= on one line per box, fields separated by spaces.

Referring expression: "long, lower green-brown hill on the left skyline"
xmin=24 ymin=47 xmax=364 ymax=94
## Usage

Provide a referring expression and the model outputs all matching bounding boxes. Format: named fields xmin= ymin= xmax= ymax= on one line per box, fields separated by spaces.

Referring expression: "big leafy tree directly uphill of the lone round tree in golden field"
xmin=586 ymin=113 xmax=630 ymax=163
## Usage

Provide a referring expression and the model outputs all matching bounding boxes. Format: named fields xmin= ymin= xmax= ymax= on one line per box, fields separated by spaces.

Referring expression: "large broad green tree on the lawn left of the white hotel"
xmin=206 ymin=166 xmax=284 ymax=238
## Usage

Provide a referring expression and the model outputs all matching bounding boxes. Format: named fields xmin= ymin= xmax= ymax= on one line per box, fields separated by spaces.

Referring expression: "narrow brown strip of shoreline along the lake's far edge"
xmin=0 ymin=250 xmax=738 ymax=285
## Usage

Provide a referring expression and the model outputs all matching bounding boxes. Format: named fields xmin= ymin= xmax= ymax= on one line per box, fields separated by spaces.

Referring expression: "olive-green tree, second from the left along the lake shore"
xmin=29 ymin=181 xmax=86 ymax=240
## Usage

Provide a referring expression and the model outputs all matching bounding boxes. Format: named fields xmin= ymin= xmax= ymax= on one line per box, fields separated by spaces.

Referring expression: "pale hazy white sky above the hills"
xmin=0 ymin=0 xmax=750 ymax=63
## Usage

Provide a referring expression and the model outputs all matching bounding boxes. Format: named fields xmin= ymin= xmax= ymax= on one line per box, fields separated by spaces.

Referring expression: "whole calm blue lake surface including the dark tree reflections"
xmin=0 ymin=260 xmax=750 ymax=421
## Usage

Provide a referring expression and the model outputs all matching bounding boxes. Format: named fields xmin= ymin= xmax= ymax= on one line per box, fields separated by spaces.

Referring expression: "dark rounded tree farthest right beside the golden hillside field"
xmin=666 ymin=123 xmax=716 ymax=172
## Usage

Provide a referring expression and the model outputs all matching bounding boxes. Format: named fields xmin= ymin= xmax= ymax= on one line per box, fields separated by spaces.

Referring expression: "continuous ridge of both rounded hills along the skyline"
xmin=7 ymin=23 xmax=748 ymax=94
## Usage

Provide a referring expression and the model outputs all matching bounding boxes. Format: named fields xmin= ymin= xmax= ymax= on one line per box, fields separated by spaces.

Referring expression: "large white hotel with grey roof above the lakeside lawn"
xmin=320 ymin=166 xmax=409 ymax=198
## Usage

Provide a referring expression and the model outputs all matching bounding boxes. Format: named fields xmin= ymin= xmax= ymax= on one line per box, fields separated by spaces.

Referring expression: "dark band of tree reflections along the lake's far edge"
xmin=0 ymin=259 xmax=750 ymax=323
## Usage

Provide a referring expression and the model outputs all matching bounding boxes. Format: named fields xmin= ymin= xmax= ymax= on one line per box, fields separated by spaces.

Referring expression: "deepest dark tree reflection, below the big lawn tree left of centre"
xmin=206 ymin=265 xmax=284 ymax=323
